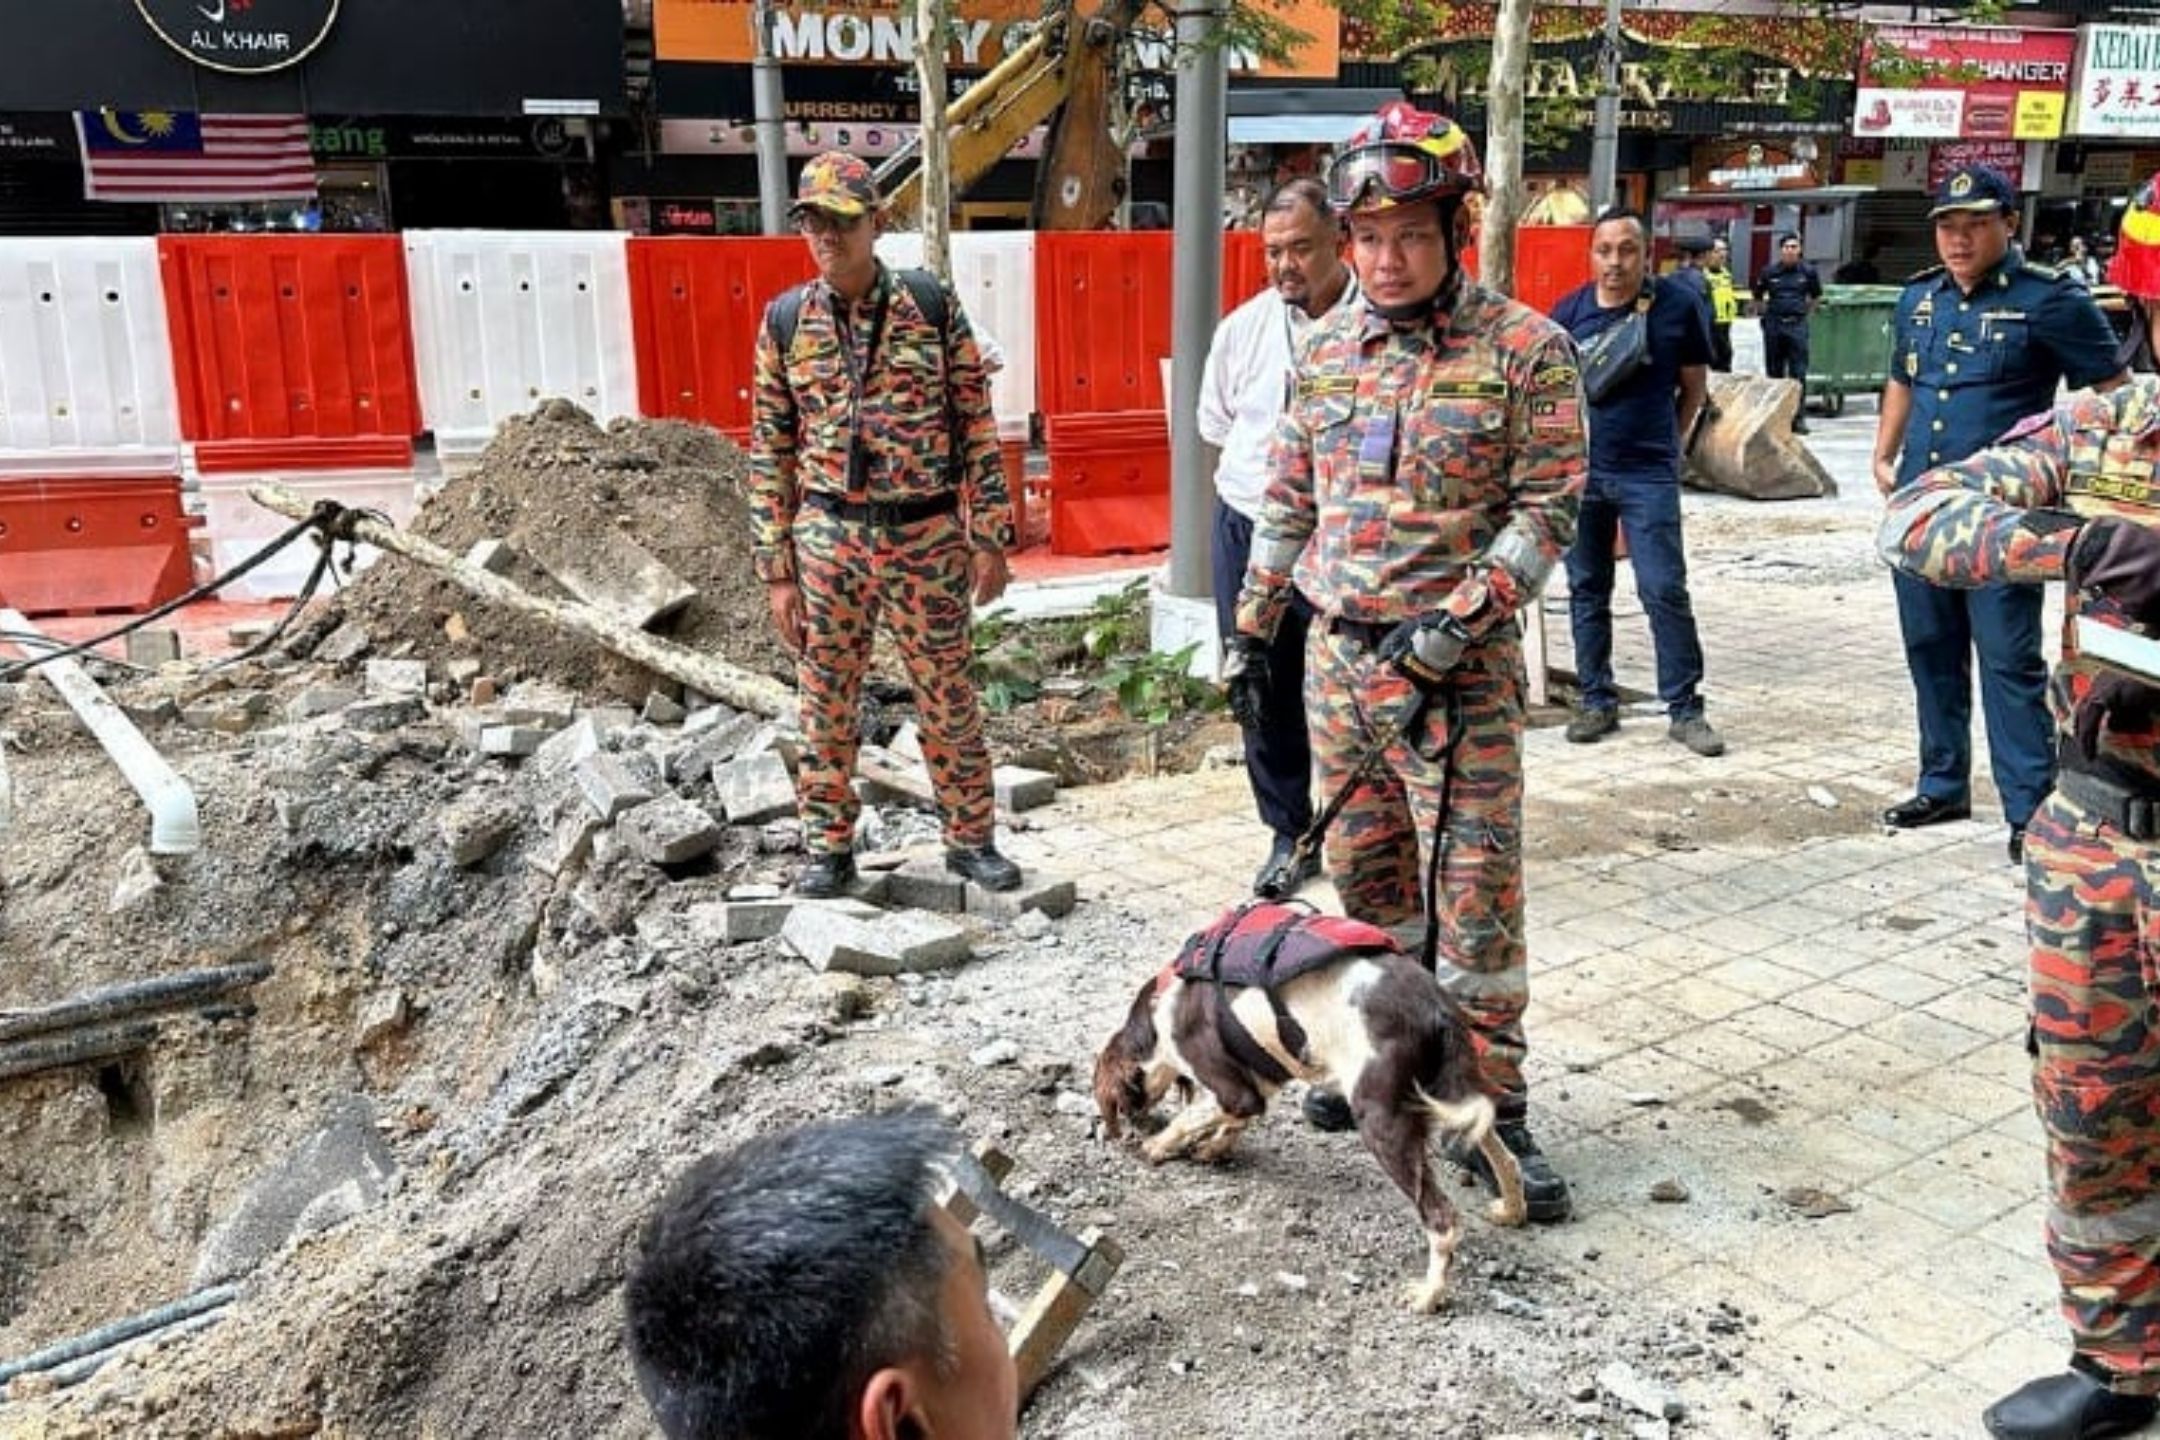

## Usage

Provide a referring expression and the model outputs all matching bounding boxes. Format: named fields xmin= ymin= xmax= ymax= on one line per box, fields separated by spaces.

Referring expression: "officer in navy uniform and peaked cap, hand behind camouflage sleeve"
xmin=1875 ymin=166 xmax=2121 ymax=861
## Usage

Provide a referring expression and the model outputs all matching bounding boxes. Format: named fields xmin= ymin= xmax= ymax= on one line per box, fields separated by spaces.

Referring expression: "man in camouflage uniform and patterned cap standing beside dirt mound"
xmin=750 ymin=151 xmax=1020 ymax=896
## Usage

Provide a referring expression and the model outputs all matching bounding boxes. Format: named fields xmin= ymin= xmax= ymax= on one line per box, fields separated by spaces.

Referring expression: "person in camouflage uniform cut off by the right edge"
xmin=1881 ymin=177 xmax=2160 ymax=1440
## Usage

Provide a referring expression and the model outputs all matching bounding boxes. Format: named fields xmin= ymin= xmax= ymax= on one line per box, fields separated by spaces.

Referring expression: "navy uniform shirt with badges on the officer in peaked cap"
xmin=1890 ymin=246 xmax=2121 ymax=486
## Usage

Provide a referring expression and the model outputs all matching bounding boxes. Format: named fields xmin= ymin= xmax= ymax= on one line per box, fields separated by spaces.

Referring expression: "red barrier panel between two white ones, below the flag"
xmin=158 ymin=235 xmax=421 ymax=466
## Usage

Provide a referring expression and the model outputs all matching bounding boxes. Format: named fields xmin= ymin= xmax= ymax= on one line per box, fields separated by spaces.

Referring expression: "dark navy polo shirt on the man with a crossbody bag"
xmin=1553 ymin=276 xmax=1711 ymax=481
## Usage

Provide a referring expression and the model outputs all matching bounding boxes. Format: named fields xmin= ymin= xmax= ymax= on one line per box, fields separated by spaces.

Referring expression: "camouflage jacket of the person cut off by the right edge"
xmin=1877 ymin=376 xmax=2160 ymax=775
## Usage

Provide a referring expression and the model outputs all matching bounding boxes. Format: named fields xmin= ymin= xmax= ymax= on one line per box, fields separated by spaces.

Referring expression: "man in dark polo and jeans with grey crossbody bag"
xmin=1553 ymin=209 xmax=1726 ymax=756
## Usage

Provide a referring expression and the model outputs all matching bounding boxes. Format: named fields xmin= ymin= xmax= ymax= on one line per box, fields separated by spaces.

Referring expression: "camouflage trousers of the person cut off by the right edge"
xmin=2026 ymin=792 xmax=2160 ymax=1395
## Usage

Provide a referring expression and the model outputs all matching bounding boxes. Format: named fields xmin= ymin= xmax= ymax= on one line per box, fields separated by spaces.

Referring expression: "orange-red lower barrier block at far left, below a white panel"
xmin=0 ymin=475 xmax=201 ymax=615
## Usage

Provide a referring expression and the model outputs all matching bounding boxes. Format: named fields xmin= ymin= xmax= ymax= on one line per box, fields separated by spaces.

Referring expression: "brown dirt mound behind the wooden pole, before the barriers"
xmin=330 ymin=399 xmax=795 ymax=702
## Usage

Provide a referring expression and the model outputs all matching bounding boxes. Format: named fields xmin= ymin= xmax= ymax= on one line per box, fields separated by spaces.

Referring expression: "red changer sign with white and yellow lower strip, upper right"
xmin=1853 ymin=26 xmax=2078 ymax=140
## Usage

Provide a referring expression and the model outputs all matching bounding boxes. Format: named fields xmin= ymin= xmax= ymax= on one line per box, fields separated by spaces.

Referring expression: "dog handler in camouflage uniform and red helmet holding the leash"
xmin=1225 ymin=101 xmax=1585 ymax=1222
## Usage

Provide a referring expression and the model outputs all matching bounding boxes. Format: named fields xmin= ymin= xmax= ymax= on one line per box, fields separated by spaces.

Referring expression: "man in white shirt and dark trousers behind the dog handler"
xmin=1199 ymin=179 xmax=1356 ymax=898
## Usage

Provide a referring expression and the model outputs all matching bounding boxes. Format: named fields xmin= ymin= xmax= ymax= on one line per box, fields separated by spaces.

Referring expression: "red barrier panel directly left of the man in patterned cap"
xmin=631 ymin=235 xmax=816 ymax=438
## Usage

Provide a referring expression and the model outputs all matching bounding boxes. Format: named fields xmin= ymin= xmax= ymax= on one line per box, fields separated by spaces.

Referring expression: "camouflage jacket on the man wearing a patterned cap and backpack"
xmin=750 ymin=266 xmax=1013 ymax=581
